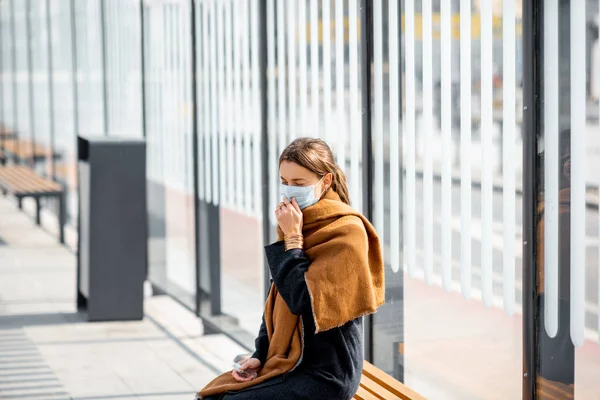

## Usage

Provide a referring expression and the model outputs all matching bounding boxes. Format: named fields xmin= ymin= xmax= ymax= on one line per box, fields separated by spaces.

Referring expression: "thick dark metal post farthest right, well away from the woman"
xmin=522 ymin=0 xmax=544 ymax=400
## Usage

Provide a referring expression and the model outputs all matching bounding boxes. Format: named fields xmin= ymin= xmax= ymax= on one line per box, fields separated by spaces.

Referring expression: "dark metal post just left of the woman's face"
xmin=257 ymin=0 xmax=275 ymax=296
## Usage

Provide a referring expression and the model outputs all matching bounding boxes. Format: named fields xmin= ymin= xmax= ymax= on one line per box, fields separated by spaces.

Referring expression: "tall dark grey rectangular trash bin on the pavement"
xmin=77 ymin=136 xmax=147 ymax=321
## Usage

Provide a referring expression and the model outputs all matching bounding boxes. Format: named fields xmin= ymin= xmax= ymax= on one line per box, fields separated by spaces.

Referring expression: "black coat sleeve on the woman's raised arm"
xmin=265 ymin=242 xmax=312 ymax=315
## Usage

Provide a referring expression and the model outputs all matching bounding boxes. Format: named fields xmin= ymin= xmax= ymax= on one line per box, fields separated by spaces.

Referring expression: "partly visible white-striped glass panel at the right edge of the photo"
xmin=537 ymin=0 xmax=600 ymax=399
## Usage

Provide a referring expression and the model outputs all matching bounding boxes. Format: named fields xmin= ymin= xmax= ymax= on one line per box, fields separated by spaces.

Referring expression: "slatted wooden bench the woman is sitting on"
xmin=354 ymin=361 xmax=425 ymax=400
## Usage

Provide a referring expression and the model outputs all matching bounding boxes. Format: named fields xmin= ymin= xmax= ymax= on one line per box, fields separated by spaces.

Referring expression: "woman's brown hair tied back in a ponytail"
xmin=279 ymin=138 xmax=350 ymax=205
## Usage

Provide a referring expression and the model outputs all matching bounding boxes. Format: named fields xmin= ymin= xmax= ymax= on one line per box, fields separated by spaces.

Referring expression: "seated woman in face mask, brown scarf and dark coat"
xmin=198 ymin=138 xmax=384 ymax=400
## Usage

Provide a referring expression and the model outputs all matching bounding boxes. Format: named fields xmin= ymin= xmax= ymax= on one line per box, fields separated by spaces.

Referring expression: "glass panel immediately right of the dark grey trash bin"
xmin=145 ymin=2 xmax=196 ymax=308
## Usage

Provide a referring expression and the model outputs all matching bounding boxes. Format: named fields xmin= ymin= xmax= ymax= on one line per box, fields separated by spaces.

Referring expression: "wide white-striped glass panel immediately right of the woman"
xmin=373 ymin=0 xmax=522 ymax=399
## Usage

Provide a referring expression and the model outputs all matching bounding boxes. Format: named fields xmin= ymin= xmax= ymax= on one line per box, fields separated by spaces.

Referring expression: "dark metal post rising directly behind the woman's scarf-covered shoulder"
xmin=360 ymin=0 xmax=373 ymax=361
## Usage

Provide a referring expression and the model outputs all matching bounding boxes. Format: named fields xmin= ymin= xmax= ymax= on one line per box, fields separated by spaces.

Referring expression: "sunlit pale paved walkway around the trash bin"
xmin=0 ymin=196 xmax=245 ymax=400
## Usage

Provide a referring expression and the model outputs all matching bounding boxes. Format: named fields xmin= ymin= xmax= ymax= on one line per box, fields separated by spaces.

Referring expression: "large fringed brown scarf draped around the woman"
xmin=199 ymin=190 xmax=385 ymax=398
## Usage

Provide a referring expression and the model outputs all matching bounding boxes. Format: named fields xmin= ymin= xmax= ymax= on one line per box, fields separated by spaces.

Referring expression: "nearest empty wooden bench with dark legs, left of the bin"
xmin=0 ymin=165 xmax=66 ymax=243
